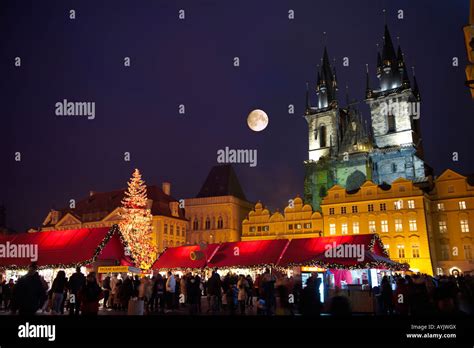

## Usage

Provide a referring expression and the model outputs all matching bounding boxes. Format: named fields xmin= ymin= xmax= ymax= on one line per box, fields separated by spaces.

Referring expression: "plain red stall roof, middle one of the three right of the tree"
xmin=207 ymin=239 xmax=288 ymax=268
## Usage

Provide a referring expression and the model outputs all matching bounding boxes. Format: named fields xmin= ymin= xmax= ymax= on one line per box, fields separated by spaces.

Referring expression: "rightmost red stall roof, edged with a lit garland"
xmin=278 ymin=234 xmax=404 ymax=269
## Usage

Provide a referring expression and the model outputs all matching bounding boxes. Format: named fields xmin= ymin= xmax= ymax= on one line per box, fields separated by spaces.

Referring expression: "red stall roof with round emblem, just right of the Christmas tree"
xmin=152 ymin=244 xmax=219 ymax=269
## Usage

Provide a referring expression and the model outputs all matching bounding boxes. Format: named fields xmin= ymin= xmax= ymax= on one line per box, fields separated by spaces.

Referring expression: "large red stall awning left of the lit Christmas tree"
xmin=0 ymin=227 xmax=124 ymax=269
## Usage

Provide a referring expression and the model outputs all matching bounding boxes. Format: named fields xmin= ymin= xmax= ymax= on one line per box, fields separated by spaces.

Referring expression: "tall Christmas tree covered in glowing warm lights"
xmin=119 ymin=169 xmax=156 ymax=269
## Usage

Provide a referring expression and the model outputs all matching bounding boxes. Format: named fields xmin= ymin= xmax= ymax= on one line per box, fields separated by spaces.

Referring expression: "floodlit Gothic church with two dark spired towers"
xmin=304 ymin=26 xmax=431 ymax=210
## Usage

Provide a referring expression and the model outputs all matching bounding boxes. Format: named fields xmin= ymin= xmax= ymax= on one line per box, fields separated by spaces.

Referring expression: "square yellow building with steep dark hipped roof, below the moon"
xmin=184 ymin=164 xmax=253 ymax=244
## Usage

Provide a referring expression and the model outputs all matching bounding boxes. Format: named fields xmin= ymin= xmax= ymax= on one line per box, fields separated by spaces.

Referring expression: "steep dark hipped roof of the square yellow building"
xmin=196 ymin=164 xmax=247 ymax=201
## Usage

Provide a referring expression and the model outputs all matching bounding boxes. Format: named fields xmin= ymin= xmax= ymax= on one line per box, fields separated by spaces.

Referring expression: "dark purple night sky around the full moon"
xmin=0 ymin=0 xmax=474 ymax=231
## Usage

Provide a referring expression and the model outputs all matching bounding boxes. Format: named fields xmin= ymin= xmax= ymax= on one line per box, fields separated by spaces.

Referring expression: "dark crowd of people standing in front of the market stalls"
xmin=0 ymin=263 xmax=474 ymax=316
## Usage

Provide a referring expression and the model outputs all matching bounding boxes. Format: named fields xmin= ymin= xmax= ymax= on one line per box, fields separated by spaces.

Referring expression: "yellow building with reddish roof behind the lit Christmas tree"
xmin=41 ymin=183 xmax=188 ymax=251
